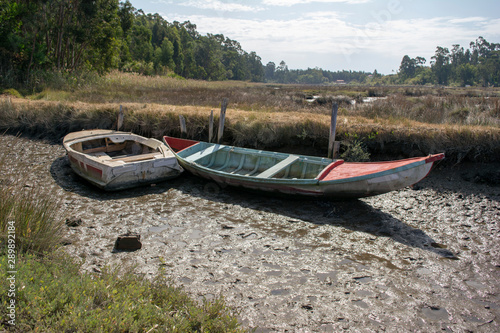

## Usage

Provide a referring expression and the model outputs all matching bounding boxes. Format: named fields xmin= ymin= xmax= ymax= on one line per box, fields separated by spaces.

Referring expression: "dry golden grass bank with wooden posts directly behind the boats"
xmin=0 ymin=94 xmax=500 ymax=162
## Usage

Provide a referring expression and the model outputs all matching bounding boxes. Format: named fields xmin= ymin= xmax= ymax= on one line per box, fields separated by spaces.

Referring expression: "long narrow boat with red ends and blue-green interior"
xmin=163 ymin=136 xmax=444 ymax=199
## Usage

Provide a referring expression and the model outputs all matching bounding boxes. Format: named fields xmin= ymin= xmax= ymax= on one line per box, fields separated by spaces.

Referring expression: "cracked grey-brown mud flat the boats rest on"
xmin=0 ymin=136 xmax=500 ymax=332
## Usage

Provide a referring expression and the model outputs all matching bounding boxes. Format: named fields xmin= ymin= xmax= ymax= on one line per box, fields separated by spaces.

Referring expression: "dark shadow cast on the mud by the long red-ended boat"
xmin=176 ymin=174 xmax=458 ymax=260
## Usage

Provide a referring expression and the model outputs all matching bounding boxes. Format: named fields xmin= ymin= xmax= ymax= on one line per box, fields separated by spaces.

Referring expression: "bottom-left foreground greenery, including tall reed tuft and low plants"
xmin=0 ymin=156 xmax=242 ymax=332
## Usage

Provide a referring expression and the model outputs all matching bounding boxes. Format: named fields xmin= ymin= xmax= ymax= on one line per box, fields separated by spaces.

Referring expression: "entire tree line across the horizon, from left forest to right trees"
xmin=0 ymin=0 xmax=500 ymax=88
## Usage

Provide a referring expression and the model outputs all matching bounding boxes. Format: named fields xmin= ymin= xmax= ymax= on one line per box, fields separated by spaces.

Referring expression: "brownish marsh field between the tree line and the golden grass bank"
xmin=24 ymin=72 xmax=500 ymax=127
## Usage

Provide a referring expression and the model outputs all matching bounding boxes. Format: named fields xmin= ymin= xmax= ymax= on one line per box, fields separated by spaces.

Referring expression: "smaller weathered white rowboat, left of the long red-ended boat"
xmin=63 ymin=129 xmax=183 ymax=190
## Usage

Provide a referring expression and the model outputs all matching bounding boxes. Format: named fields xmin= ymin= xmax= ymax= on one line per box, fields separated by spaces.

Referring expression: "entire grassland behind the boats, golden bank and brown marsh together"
xmin=0 ymin=73 xmax=500 ymax=163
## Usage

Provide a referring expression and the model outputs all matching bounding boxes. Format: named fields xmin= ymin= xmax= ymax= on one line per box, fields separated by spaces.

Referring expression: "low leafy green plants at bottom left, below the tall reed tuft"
xmin=0 ymin=254 xmax=239 ymax=332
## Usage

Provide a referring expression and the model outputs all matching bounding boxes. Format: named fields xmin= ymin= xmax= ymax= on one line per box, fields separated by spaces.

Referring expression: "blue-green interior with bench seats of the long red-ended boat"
xmin=184 ymin=143 xmax=332 ymax=179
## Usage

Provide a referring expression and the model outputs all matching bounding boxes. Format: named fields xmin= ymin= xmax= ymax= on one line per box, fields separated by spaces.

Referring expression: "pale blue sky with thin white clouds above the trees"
xmin=127 ymin=0 xmax=500 ymax=74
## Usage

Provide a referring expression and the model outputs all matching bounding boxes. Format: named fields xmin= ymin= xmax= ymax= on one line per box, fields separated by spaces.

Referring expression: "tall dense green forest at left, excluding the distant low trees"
xmin=0 ymin=0 xmax=264 ymax=86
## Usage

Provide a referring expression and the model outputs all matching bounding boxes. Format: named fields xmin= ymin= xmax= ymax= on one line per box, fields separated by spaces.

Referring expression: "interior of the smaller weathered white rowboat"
xmin=71 ymin=137 xmax=162 ymax=162
